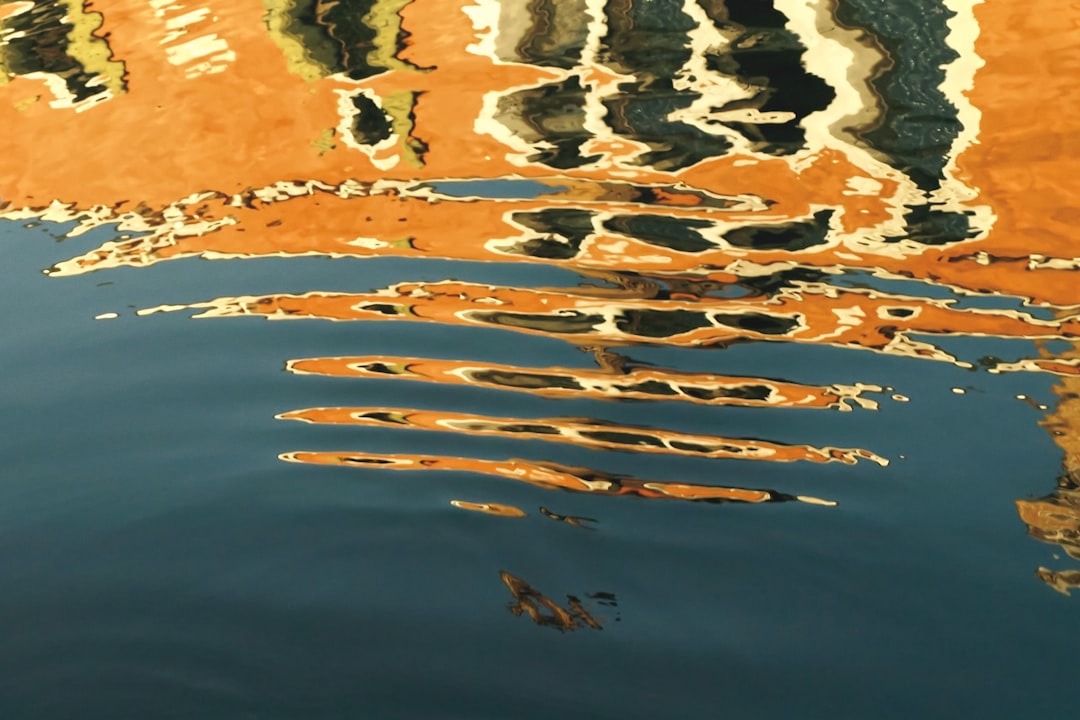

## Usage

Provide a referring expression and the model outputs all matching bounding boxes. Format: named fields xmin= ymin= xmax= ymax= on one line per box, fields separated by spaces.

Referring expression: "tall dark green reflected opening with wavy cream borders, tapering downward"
xmin=794 ymin=0 xmax=987 ymax=245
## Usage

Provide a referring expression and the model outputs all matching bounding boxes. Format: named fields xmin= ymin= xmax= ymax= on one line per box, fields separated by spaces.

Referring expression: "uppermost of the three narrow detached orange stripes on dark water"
xmin=285 ymin=355 xmax=881 ymax=411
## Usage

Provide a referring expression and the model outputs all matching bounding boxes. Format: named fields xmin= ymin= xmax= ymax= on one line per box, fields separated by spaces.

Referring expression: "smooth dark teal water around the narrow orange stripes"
xmin=0 ymin=216 xmax=1076 ymax=718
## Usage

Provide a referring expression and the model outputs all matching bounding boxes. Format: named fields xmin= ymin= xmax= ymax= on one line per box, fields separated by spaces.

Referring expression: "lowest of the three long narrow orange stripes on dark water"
xmin=279 ymin=451 xmax=836 ymax=506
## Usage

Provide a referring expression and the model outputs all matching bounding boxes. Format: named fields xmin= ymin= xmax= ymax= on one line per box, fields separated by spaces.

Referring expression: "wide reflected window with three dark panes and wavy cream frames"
xmin=482 ymin=0 xmax=832 ymax=172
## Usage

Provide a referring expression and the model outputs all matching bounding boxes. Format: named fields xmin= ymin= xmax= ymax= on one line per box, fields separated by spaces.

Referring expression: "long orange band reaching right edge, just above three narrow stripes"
xmin=139 ymin=281 xmax=1080 ymax=367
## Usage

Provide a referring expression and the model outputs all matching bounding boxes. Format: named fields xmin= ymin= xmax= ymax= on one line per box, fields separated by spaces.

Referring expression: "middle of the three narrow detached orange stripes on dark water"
xmin=276 ymin=407 xmax=889 ymax=466
